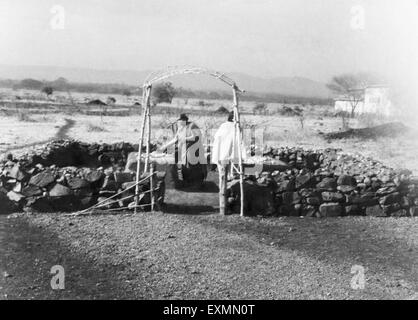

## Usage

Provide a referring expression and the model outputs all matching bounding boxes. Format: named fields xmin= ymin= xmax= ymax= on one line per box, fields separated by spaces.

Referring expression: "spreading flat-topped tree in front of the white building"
xmin=327 ymin=73 xmax=377 ymax=118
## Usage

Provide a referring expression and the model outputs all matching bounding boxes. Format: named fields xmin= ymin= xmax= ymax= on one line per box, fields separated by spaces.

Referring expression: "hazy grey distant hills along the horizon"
xmin=0 ymin=65 xmax=331 ymax=98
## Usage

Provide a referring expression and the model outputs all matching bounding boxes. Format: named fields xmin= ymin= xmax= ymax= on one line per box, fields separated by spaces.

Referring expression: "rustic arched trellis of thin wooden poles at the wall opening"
xmin=135 ymin=67 xmax=244 ymax=216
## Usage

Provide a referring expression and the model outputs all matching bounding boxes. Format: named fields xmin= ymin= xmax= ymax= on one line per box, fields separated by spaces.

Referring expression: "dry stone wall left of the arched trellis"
xmin=0 ymin=140 xmax=164 ymax=214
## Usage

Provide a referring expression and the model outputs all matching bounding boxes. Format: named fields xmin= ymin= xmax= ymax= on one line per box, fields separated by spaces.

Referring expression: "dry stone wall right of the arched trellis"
xmin=228 ymin=148 xmax=418 ymax=217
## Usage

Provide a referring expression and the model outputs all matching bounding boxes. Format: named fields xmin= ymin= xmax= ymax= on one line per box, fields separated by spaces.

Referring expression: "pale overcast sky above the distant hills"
xmin=0 ymin=0 xmax=418 ymax=81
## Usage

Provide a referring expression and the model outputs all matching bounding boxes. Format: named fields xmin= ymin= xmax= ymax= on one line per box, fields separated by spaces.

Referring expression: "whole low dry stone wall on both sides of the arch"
xmin=0 ymin=140 xmax=418 ymax=217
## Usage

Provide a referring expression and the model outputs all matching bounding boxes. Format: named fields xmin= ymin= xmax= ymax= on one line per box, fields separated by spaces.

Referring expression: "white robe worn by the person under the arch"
xmin=211 ymin=121 xmax=246 ymax=164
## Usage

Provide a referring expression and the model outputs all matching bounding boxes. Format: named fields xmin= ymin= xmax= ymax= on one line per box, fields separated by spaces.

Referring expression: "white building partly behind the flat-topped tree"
xmin=335 ymin=86 xmax=395 ymax=116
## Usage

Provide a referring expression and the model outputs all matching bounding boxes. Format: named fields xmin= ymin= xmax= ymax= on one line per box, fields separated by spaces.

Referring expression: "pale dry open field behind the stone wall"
xmin=0 ymin=107 xmax=418 ymax=175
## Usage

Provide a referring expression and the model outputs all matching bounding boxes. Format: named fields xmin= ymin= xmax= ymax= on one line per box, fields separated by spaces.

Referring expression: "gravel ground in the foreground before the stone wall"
xmin=0 ymin=213 xmax=418 ymax=299
